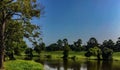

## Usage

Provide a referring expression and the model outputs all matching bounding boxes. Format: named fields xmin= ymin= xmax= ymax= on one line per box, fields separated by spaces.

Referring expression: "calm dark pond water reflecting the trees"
xmin=37 ymin=60 xmax=120 ymax=70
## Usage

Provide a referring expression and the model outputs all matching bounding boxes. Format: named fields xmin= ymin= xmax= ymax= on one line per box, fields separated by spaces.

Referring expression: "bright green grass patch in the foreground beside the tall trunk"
xmin=5 ymin=60 xmax=43 ymax=70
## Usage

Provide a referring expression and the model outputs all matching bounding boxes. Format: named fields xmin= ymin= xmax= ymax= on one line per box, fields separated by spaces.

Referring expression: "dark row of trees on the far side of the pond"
xmin=45 ymin=37 xmax=120 ymax=60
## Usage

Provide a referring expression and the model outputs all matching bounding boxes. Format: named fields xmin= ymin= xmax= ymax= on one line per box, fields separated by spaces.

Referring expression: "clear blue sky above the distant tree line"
xmin=33 ymin=0 xmax=120 ymax=45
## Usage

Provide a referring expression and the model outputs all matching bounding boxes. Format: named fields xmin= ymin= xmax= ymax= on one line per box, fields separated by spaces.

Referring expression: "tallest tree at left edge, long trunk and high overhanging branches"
xmin=0 ymin=0 xmax=40 ymax=69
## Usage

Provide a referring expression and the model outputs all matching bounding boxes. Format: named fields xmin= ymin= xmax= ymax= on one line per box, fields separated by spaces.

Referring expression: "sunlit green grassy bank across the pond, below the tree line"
xmin=41 ymin=51 xmax=120 ymax=60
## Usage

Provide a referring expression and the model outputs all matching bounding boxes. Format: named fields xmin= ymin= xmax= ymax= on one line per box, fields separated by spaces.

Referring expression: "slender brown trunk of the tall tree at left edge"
xmin=0 ymin=23 xmax=5 ymax=70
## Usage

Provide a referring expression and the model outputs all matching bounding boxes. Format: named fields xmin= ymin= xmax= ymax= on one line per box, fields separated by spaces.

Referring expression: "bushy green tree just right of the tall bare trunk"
xmin=5 ymin=20 xmax=27 ymax=59
